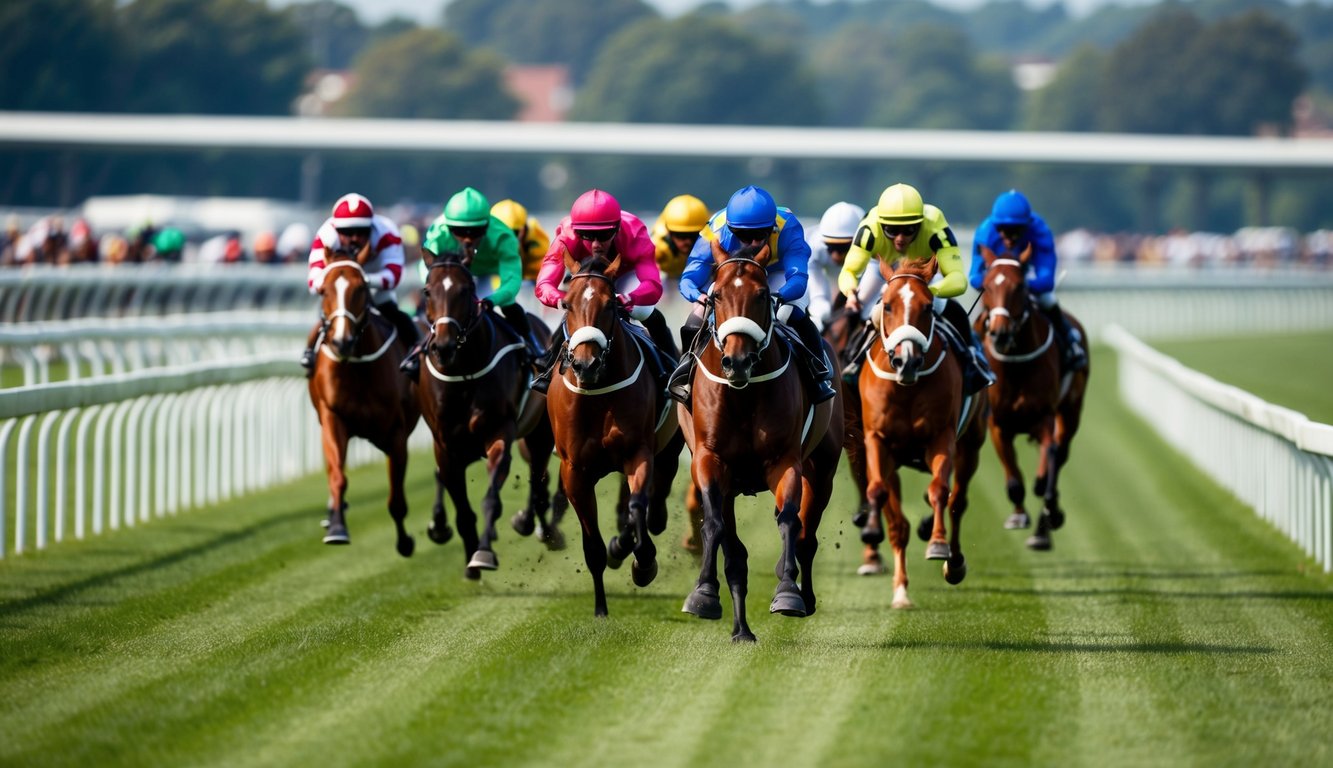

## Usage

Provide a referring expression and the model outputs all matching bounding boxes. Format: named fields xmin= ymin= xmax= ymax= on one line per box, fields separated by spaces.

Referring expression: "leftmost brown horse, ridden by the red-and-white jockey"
xmin=309 ymin=244 xmax=420 ymax=557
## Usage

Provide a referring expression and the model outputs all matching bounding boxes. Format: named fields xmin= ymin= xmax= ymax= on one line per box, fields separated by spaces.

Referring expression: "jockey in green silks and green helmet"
xmin=413 ymin=187 xmax=541 ymax=376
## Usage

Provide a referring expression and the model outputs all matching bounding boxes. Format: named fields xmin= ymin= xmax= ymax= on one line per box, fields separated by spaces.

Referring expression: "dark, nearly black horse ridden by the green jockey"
xmin=417 ymin=251 xmax=559 ymax=579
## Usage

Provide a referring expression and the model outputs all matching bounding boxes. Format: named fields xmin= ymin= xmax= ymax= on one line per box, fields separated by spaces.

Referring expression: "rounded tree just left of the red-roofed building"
xmin=339 ymin=29 xmax=519 ymax=120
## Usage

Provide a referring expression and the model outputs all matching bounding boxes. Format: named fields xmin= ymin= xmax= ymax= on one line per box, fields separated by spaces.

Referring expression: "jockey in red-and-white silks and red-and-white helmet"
xmin=301 ymin=192 xmax=417 ymax=376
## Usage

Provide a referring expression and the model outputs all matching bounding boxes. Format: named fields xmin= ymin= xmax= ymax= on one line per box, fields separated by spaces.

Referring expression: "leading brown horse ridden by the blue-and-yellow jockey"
xmin=680 ymin=243 xmax=842 ymax=643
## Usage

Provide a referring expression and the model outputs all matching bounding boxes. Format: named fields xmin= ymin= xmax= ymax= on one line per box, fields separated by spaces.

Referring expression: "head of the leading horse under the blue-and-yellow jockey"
xmin=710 ymin=241 xmax=777 ymax=387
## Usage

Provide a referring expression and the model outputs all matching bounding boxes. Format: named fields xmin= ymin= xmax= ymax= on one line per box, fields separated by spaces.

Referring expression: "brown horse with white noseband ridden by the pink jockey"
xmin=547 ymin=252 xmax=684 ymax=616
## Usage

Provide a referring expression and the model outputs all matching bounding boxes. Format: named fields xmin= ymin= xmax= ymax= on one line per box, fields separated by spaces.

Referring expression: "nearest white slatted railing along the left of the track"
xmin=0 ymin=353 xmax=431 ymax=557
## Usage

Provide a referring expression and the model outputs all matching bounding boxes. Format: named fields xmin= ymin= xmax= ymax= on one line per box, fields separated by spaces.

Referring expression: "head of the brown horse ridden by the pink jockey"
xmin=563 ymin=249 xmax=623 ymax=387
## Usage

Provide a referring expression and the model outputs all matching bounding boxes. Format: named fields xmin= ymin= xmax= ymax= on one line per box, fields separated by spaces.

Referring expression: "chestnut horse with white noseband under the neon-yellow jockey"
xmin=858 ymin=257 xmax=988 ymax=608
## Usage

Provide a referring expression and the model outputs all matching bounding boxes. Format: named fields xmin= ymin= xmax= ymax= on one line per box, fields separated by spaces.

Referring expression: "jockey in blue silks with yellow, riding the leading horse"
xmin=669 ymin=185 xmax=836 ymax=403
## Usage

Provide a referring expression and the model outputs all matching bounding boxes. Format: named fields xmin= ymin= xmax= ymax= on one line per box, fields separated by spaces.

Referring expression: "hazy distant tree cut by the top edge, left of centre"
xmin=444 ymin=0 xmax=657 ymax=84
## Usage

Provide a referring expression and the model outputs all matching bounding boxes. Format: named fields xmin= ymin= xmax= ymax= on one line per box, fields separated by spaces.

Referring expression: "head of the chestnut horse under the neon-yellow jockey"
xmin=880 ymin=256 xmax=936 ymax=384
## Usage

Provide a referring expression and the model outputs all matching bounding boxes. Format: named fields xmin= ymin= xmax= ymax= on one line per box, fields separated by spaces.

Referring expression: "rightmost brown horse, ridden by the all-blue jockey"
xmin=977 ymin=244 xmax=1090 ymax=549
